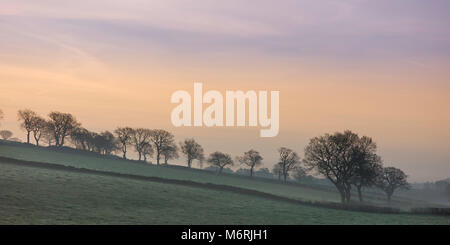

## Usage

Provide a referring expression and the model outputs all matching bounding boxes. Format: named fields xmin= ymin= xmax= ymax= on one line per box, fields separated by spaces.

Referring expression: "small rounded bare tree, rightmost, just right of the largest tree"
xmin=377 ymin=167 xmax=410 ymax=202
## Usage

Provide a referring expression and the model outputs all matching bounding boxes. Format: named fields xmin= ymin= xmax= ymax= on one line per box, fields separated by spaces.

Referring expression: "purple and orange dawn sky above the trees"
xmin=0 ymin=0 xmax=450 ymax=181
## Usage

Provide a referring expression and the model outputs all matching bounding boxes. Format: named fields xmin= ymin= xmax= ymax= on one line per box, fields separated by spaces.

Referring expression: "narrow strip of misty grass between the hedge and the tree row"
xmin=0 ymin=143 xmax=432 ymax=208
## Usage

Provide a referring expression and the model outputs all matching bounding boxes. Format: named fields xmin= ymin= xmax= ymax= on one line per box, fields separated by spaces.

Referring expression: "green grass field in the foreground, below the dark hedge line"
xmin=0 ymin=163 xmax=450 ymax=224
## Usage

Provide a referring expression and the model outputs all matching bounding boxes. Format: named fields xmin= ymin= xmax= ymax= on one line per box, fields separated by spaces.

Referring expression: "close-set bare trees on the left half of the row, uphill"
xmin=12 ymin=109 xmax=204 ymax=167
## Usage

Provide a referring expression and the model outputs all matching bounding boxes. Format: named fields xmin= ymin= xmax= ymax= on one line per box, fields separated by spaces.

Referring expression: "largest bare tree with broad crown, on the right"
xmin=304 ymin=130 xmax=374 ymax=203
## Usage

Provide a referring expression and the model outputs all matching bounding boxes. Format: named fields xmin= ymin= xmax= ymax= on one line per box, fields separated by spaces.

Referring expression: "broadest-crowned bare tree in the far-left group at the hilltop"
xmin=48 ymin=111 xmax=81 ymax=147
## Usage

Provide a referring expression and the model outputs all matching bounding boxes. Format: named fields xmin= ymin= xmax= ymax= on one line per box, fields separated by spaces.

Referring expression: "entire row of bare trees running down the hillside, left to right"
xmin=0 ymin=109 xmax=418 ymax=203
